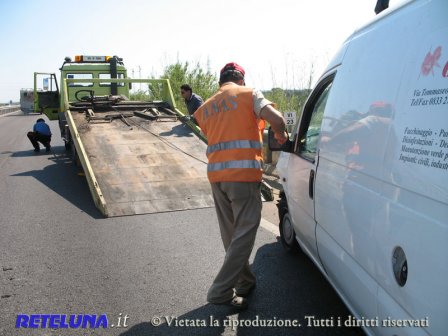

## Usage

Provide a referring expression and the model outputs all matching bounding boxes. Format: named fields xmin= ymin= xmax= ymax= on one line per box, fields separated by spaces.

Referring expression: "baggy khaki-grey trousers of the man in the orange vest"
xmin=207 ymin=182 xmax=262 ymax=303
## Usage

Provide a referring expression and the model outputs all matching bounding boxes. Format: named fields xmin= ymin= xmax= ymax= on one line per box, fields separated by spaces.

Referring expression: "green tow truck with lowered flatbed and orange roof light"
xmin=34 ymin=56 xmax=272 ymax=217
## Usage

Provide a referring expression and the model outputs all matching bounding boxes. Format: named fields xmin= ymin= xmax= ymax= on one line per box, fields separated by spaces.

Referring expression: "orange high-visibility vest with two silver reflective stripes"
xmin=194 ymin=84 xmax=264 ymax=183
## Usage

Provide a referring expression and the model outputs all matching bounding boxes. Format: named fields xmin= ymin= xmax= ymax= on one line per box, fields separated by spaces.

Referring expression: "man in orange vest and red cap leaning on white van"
xmin=194 ymin=63 xmax=288 ymax=309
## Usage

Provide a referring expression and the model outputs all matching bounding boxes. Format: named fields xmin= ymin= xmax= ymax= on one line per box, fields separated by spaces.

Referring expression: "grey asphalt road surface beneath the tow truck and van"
xmin=0 ymin=113 xmax=363 ymax=336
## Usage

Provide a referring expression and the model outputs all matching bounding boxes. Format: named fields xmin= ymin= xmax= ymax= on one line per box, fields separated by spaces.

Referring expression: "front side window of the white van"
xmin=295 ymin=75 xmax=334 ymax=162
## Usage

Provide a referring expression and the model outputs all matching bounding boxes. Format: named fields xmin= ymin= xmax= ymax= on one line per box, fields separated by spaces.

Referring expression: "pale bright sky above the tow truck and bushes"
xmin=0 ymin=0 xmax=403 ymax=102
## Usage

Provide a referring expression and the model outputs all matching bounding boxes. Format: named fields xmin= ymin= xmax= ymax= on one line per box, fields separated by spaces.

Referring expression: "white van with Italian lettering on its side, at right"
xmin=269 ymin=0 xmax=448 ymax=335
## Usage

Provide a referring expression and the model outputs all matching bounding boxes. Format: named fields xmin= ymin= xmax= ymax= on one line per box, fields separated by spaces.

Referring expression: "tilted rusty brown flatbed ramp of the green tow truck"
xmin=67 ymin=102 xmax=213 ymax=217
